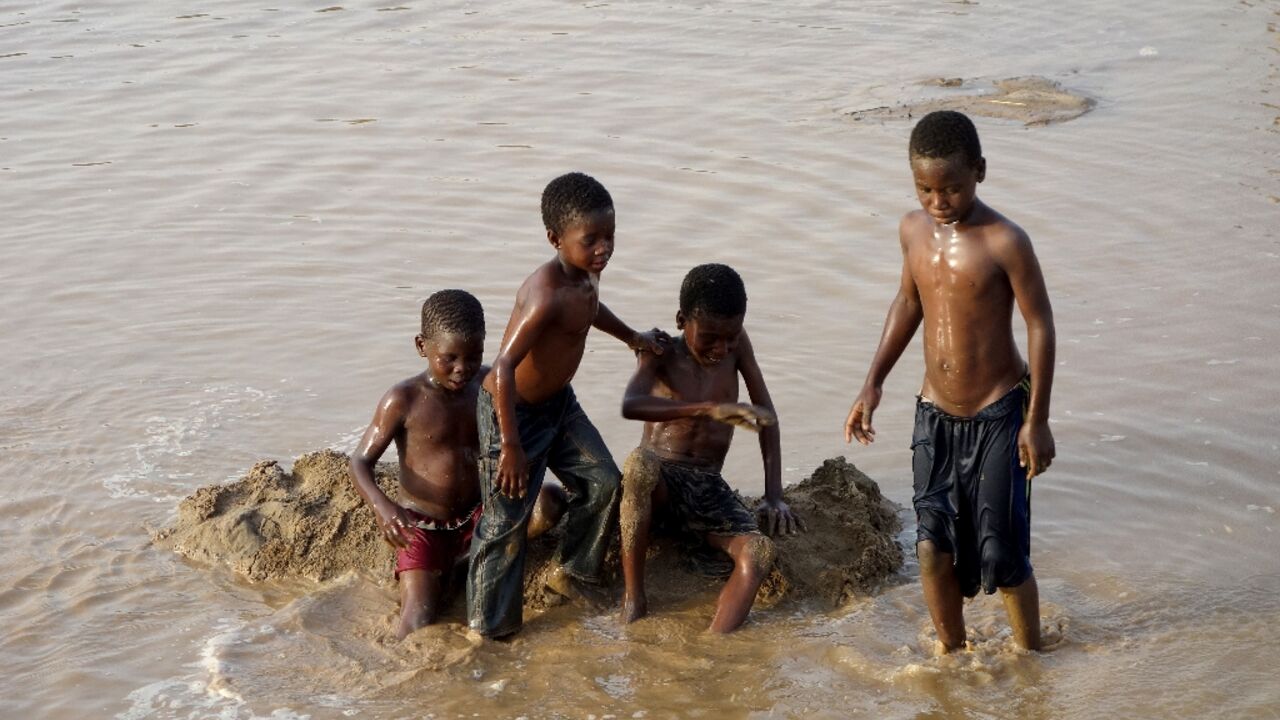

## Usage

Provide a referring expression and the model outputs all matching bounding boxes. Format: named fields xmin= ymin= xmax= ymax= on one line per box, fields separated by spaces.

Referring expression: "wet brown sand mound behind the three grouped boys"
xmin=154 ymin=450 xmax=902 ymax=609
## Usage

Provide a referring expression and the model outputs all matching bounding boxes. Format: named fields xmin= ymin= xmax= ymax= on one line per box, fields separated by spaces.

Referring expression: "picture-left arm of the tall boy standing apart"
xmin=845 ymin=221 xmax=924 ymax=445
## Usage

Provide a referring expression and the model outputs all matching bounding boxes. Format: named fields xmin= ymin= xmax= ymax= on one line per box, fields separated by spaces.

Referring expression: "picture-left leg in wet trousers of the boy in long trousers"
xmin=467 ymin=389 xmax=554 ymax=638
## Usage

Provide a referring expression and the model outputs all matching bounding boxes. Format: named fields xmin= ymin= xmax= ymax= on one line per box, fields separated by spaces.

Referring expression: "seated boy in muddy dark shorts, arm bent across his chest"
xmin=622 ymin=264 xmax=804 ymax=633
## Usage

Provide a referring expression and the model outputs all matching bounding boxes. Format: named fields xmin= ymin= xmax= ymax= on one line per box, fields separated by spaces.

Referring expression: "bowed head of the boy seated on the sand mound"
xmin=676 ymin=263 xmax=746 ymax=365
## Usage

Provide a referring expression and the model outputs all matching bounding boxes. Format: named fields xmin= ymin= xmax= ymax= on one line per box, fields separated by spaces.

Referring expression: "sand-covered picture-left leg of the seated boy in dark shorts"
xmin=618 ymin=448 xmax=667 ymax=623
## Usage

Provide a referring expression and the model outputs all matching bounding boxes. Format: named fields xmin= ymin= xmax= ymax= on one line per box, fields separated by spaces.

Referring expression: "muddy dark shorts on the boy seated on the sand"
xmin=650 ymin=450 xmax=760 ymax=578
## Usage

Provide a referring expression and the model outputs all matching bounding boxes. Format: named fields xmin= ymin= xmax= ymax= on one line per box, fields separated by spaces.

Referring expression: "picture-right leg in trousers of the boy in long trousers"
xmin=547 ymin=391 xmax=622 ymax=584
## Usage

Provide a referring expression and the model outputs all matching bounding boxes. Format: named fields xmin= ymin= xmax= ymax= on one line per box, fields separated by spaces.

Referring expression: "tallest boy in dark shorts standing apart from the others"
xmin=845 ymin=110 xmax=1055 ymax=652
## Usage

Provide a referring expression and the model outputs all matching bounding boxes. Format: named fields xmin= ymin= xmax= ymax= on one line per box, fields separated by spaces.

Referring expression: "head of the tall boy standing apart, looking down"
xmin=909 ymin=110 xmax=987 ymax=224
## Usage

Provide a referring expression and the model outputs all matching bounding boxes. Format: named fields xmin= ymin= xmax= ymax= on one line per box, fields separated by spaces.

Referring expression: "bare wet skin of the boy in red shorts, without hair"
xmin=351 ymin=333 xmax=484 ymax=638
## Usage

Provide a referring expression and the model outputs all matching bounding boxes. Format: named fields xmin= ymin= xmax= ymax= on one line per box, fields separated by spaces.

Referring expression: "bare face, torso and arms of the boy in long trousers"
xmin=484 ymin=209 xmax=664 ymax=497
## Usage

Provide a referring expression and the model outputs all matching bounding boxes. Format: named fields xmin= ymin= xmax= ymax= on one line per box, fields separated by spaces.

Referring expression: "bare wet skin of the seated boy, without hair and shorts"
xmin=622 ymin=313 xmax=804 ymax=632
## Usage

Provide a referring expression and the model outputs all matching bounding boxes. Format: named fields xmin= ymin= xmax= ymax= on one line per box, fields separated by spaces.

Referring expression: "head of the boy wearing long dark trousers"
xmin=543 ymin=173 xmax=614 ymax=273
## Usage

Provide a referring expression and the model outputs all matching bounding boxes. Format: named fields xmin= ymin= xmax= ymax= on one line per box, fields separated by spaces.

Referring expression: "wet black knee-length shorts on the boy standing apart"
xmin=911 ymin=378 xmax=1032 ymax=597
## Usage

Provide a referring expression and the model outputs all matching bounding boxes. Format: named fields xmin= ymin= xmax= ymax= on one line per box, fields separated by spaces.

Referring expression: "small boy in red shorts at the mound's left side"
xmin=351 ymin=290 xmax=565 ymax=638
